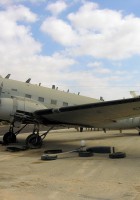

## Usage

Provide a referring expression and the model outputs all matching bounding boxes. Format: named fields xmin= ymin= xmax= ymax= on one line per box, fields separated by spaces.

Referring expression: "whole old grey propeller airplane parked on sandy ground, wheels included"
xmin=0 ymin=75 xmax=140 ymax=148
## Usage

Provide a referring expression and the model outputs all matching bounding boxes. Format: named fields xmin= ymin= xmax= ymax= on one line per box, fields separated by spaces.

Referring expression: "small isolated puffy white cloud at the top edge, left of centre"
xmin=46 ymin=0 xmax=67 ymax=15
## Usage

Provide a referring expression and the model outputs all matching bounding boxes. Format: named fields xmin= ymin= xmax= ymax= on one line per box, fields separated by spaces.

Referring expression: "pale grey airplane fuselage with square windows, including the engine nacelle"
xmin=0 ymin=77 xmax=140 ymax=129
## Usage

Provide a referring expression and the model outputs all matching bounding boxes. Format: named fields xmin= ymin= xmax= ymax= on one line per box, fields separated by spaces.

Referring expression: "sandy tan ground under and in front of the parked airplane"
xmin=0 ymin=129 xmax=140 ymax=200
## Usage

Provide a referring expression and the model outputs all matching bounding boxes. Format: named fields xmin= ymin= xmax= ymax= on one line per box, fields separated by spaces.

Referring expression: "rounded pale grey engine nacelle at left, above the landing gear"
xmin=0 ymin=97 xmax=46 ymax=122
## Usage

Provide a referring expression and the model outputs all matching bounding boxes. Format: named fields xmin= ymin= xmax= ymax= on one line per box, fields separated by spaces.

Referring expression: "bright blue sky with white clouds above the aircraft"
xmin=0 ymin=0 xmax=140 ymax=100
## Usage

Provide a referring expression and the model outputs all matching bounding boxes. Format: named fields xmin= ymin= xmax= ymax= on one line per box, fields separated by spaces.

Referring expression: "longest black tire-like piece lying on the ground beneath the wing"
xmin=86 ymin=146 xmax=115 ymax=153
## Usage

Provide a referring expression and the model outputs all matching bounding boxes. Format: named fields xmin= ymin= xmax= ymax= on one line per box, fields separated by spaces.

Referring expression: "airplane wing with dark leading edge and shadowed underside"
xmin=34 ymin=98 xmax=140 ymax=127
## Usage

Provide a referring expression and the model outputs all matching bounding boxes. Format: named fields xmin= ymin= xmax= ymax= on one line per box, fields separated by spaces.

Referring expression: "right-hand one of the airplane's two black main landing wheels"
xmin=26 ymin=133 xmax=42 ymax=149
